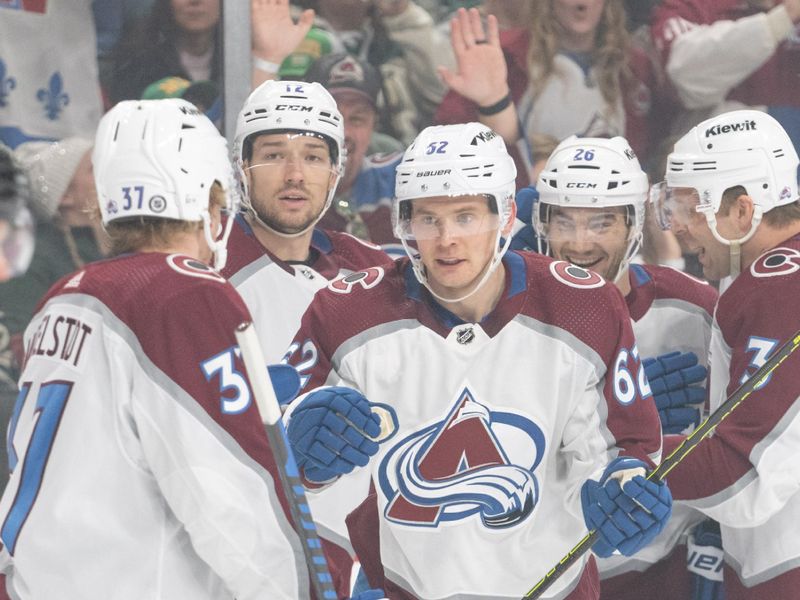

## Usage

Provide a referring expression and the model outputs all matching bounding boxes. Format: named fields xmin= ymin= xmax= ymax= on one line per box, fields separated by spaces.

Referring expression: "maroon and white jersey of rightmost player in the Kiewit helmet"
xmin=668 ymin=236 xmax=800 ymax=600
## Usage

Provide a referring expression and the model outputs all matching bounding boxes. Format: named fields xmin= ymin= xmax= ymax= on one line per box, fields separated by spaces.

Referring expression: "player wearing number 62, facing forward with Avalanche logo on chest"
xmin=280 ymin=123 xmax=671 ymax=598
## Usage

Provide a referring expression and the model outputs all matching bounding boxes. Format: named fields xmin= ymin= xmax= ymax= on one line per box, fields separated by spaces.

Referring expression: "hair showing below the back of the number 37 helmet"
xmin=106 ymin=181 xmax=226 ymax=255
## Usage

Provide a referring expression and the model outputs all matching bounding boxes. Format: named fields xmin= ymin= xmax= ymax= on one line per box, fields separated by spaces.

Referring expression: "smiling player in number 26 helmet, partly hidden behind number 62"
xmin=533 ymin=136 xmax=717 ymax=600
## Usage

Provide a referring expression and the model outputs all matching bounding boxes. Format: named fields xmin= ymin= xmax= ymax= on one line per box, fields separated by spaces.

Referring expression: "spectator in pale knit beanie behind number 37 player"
xmin=0 ymin=137 xmax=105 ymax=486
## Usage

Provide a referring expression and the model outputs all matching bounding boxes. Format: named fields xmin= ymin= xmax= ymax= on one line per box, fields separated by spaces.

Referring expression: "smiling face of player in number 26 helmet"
xmin=546 ymin=206 xmax=629 ymax=281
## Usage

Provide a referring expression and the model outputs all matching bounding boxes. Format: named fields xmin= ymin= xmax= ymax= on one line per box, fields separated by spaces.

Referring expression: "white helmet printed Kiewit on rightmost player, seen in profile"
xmin=650 ymin=110 xmax=798 ymax=275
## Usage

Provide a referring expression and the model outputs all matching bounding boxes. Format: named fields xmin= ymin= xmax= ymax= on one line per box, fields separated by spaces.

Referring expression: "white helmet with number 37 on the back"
xmin=92 ymin=98 xmax=238 ymax=269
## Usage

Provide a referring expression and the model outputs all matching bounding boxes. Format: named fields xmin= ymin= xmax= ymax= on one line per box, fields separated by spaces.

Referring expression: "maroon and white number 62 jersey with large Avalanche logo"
xmin=289 ymin=252 xmax=661 ymax=599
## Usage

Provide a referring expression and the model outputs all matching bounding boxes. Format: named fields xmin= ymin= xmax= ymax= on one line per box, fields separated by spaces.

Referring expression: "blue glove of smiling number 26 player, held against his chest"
xmin=642 ymin=352 xmax=708 ymax=433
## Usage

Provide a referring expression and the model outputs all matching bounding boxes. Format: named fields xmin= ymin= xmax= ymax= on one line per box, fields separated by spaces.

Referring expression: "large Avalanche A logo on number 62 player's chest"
xmin=378 ymin=388 xmax=545 ymax=529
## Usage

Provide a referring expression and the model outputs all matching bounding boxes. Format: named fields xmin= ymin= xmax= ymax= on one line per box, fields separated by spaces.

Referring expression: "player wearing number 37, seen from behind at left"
xmin=0 ymin=99 xmax=340 ymax=600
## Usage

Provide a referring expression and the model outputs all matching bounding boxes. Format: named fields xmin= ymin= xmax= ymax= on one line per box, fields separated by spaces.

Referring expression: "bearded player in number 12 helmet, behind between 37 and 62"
xmin=222 ymin=81 xmax=391 ymax=362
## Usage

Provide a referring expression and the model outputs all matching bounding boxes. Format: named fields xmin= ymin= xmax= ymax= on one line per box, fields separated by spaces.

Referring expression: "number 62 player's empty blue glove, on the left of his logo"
xmin=287 ymin=387 xmax=381 ymax=483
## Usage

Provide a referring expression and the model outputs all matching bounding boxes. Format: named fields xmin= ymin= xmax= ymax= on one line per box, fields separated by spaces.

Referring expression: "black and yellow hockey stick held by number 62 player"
xmin=522 ymin=331 xmax=800 ymax=600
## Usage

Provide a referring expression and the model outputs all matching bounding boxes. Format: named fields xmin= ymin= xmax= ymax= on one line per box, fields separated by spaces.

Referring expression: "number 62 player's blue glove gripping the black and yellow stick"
xmin=581 ymin=457 xmax=672 ymax=558
